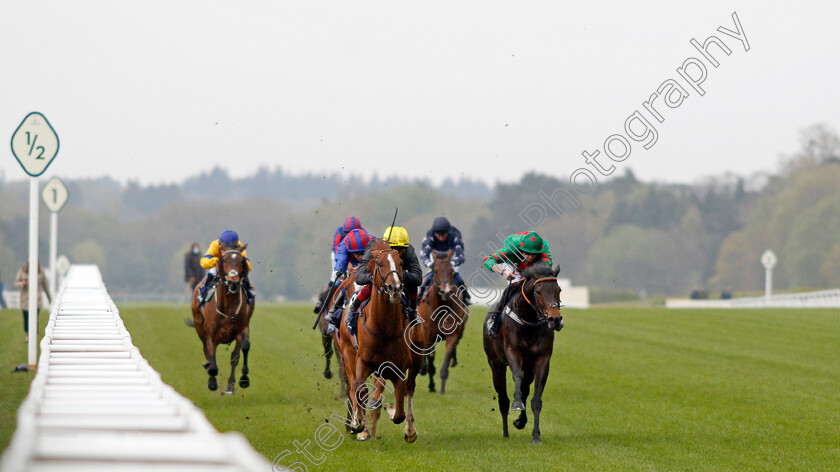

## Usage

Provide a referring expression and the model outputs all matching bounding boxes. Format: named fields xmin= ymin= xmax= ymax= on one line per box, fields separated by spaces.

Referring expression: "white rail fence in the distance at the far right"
xmin=665 ymin=289 xmax=840 ymax=308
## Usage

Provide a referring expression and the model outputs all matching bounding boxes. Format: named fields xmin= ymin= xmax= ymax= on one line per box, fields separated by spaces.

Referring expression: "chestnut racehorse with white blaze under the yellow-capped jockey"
xmin=338 ymin=239 xmax=422 ymax=442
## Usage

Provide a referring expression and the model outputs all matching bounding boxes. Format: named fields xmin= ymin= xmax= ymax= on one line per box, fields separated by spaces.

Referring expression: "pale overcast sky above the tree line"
xmin=0 ymin=0 xmax=840 ymax=187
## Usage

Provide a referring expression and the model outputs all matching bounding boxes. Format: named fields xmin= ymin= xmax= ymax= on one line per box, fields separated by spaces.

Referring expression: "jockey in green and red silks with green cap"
xmin=484 ymin=231 xmax=551 ymax=337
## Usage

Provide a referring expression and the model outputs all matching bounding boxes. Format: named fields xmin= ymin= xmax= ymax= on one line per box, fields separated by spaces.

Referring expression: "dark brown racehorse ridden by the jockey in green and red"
xmin=484 ymin=265 xmax=563 ymax=443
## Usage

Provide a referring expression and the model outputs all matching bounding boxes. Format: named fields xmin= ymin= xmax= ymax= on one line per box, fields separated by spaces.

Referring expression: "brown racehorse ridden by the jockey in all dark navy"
xmin=411 ymin=250 xmax=469 ymax=394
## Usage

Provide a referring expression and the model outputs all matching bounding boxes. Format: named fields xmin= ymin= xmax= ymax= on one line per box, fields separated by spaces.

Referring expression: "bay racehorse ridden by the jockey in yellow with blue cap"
xmin=192 ymin=244 xmax=256 ymax=394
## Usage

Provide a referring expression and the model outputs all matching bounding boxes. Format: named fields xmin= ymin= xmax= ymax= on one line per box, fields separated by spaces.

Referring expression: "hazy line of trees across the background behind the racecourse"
xmin=0 ymin=125 xmax=840 ymax=299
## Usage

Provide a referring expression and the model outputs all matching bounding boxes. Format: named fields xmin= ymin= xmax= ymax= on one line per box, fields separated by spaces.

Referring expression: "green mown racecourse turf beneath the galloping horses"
xmin=0 ymin=304 xmax=840 ymax=472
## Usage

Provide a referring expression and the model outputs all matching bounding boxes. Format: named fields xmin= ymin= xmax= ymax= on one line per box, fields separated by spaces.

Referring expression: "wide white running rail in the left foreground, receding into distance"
xmin=0 ymin=265 xmax=277 ymax=472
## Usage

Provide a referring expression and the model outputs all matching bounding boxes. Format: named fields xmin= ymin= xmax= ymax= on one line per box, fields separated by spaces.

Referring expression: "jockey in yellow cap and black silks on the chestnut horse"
xmin=347 ymin=226 xmax=423 ymax=329
